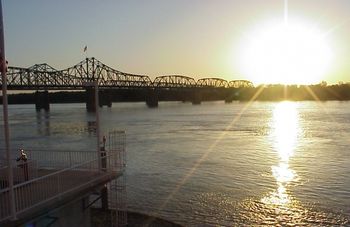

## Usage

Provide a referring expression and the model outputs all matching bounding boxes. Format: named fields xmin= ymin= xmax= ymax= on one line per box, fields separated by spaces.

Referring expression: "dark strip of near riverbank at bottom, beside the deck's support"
xmin=91 ymin=208 xmax=181 ymax=227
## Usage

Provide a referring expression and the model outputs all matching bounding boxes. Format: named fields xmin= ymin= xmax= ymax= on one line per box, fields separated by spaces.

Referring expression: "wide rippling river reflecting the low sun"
xmin=0 ymin=101 xmax=350 ymax=226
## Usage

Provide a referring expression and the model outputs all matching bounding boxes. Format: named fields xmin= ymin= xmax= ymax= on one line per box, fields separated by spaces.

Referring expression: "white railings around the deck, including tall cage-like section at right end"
xmin=0 ymin=131 xmax=126 ymax=224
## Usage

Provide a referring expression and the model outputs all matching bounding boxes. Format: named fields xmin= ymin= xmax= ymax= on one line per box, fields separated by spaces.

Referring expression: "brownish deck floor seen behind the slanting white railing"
xmin=0 ymin=169 xmax=117 ymax=225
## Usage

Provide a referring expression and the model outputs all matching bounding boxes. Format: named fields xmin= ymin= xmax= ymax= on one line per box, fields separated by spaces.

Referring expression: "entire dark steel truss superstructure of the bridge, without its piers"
xmin=0 ymin=57 xmax=253 ymax=90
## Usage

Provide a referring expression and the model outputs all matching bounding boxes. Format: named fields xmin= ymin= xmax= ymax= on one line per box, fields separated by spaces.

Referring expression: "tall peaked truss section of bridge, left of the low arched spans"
xmin=7 ymin=58 xmax=152 ymax=90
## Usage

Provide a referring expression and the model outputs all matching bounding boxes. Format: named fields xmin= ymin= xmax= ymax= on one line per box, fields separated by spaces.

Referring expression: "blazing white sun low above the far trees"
xmin=238 ymin=19 xmax=332 ymax=84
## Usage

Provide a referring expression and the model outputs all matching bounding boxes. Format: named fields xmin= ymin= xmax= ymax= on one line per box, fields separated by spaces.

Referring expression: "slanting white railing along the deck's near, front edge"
xmin=0 ymin=152 xmax=117 ymax=222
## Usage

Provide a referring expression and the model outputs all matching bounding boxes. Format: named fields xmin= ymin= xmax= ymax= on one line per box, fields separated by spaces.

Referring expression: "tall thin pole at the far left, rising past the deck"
xmin=0 ymin=0 xmax=16 ymax=219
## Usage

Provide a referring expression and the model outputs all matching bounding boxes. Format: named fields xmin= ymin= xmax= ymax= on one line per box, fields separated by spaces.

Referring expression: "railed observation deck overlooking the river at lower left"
xmin=0 ymin=132 xmax=125 ymax=226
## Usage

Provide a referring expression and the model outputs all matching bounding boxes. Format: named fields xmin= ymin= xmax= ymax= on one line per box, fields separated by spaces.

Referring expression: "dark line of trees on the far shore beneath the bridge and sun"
xmin=0 ymin=84 xmax=350 ymax=104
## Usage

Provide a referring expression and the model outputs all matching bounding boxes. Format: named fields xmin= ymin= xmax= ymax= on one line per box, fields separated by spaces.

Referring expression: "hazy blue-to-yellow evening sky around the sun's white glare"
xmin=2 ymin=0 xmax=350 ymax=84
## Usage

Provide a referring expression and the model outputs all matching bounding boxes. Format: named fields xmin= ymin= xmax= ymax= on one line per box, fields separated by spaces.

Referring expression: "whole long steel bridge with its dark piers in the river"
xmin=0 ymin=57 xmax=253 ymax=110
